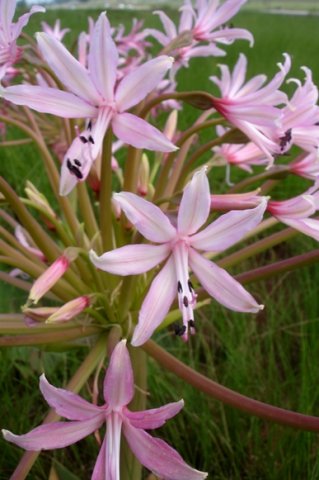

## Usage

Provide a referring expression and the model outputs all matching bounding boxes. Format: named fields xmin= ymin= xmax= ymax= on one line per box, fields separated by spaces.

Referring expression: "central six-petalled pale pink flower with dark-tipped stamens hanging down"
xmin=90 ymin=168 xmax=266 ymax=346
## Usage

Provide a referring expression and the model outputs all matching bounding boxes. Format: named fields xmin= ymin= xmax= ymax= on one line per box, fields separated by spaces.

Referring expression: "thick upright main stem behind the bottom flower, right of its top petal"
xmin=121 ymin=346 xmax=147 ymax=480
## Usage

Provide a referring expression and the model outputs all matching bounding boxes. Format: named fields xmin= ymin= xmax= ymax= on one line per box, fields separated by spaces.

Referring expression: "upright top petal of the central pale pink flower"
xmin=177 ymin=167 xmax=211 ymax=235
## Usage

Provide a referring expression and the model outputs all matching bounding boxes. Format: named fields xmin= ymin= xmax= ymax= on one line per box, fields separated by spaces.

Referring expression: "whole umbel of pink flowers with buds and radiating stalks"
xmin=0 ymin=0 xmax=319 ymax=480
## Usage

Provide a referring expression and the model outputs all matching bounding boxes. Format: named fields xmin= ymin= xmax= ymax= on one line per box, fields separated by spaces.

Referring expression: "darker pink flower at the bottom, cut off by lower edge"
xmin=2 ymin=340 xmax=207 ymax=480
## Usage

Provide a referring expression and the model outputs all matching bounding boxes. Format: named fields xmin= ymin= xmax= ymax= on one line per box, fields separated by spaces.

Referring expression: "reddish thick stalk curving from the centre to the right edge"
xmin=143 ymin=340 xmax=319 ymax=432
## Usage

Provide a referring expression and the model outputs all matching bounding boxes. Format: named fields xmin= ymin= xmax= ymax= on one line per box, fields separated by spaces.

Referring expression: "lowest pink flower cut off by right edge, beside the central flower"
xmin=267 ymin=192 xmax=319 ymax=241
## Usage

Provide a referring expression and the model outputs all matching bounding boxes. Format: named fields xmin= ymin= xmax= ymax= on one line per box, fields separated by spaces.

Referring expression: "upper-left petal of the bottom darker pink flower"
xmin=40 ymin=374 xmax=102 ymax=420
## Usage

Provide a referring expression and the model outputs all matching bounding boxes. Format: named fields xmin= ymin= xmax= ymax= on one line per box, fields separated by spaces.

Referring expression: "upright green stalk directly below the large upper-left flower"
xmin=99 ymin=128 xmax=113 ymax=251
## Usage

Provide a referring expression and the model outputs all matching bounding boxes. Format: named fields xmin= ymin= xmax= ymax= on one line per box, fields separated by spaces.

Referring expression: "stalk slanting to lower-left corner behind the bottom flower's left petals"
xmin=10 ymin=335 xmax=106 ymax=480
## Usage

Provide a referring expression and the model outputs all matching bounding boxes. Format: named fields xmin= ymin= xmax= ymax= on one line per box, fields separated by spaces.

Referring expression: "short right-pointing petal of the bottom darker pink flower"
xmin=125 ymin=400 xmax=184 ymax=430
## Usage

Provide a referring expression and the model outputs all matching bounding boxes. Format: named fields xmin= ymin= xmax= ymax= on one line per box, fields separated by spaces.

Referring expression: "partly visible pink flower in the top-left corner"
xmin=0 ymin=0 xmax=45 ymax=65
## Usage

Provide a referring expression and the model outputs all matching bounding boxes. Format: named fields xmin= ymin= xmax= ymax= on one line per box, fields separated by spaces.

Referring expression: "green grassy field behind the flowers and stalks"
xmin=0 ymin=7 xmax=319 ymax=480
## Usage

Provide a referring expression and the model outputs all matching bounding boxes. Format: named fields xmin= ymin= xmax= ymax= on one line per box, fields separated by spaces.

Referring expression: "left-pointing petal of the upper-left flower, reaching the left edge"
xmin=0 ymin=85 xmax=97 ymax=118
